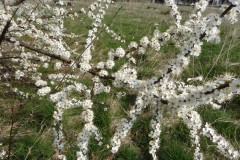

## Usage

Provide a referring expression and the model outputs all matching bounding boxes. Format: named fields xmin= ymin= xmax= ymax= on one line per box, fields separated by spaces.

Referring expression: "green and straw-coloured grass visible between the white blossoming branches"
xmin=0 ymin=3 xmax=240 ymax=160
